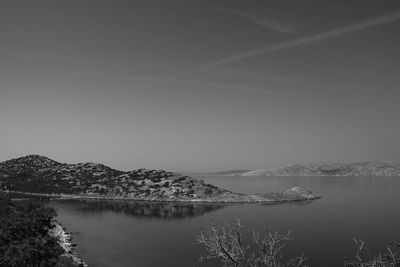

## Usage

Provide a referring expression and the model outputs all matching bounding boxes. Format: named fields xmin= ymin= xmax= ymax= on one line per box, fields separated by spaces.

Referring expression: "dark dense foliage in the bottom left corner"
xmin=0 ymin=196 xmax=64 ymax=267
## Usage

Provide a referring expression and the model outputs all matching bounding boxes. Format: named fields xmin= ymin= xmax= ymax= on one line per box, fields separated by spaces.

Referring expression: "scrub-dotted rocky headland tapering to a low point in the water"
xmin=0 ymin=155 xmax=318 ymax=203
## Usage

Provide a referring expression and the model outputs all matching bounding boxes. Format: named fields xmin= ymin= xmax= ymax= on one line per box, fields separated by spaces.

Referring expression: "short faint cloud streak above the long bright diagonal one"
xmin=216 ymin=8 xmax=294 ymax=34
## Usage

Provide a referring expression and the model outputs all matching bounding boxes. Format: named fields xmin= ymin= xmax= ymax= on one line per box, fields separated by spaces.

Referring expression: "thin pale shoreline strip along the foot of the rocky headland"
xmin=0 ymin=190 xmax=321 ymax=204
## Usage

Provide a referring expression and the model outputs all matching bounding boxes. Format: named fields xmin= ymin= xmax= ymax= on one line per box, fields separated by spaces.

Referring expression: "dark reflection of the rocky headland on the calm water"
xmin=52 ymin=200 xmax=228 ymax=220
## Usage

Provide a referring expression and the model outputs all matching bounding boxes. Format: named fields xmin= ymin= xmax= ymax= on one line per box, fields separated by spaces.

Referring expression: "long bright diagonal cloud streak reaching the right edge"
xmin=203 ymin=10 xmax=400 ymax=69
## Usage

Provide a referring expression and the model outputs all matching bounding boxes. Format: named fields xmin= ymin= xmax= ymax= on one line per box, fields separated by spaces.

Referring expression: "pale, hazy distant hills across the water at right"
xmin=242 ymin=162 xmax=400 ymax=176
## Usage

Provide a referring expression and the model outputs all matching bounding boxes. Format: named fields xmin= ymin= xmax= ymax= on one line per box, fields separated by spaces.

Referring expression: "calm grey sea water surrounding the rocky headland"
xmin=50 ymin=176 xmax=400 ymax=267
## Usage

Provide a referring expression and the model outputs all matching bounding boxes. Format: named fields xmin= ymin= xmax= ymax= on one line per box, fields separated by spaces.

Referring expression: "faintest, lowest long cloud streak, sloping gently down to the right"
xmin=76 ymin=73 xmax=296 ymax=97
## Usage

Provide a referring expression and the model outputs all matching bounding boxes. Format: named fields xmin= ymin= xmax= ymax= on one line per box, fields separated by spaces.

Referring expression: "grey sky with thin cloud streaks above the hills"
xmin=0 ymin=0 xmax=400 ymax=172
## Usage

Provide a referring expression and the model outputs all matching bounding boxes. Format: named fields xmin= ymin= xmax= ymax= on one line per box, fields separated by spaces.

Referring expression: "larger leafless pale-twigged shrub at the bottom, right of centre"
xmin=197 ymin=219 xmax=306 ymax=267
